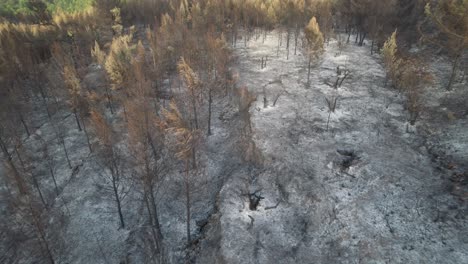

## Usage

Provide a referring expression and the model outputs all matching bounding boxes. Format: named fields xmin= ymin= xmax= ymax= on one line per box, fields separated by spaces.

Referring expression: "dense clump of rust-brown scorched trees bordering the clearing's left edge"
xmin=91 ymin=8 xmax=233 ymax=256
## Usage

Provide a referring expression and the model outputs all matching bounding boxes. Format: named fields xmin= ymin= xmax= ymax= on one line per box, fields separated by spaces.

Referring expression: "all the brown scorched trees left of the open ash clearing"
xmin=0 ymin=2 xmax=233 ymax=263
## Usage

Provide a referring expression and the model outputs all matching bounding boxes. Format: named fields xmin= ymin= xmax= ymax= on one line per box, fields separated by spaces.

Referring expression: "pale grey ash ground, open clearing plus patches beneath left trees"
xmin=0 ymin=31 xmax=468 ymax=264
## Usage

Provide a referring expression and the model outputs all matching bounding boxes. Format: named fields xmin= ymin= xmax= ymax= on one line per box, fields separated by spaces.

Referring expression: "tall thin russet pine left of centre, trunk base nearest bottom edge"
xmin=126 ymin=42 xmax=166 ymax=255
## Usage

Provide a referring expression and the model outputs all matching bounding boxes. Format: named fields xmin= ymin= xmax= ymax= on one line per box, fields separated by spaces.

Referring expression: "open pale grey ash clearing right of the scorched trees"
xmin=199 ymin=32 xmax=468 ymax=263
